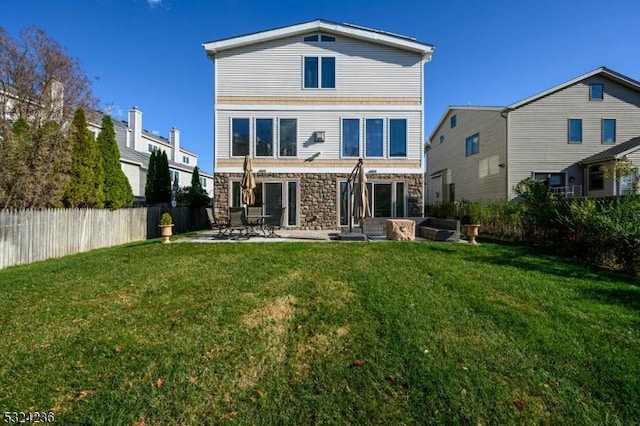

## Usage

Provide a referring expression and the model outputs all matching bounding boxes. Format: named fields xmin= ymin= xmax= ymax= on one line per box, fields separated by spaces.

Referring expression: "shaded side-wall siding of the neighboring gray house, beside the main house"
xmin=427 ymin=108 xmax=506 ymax=203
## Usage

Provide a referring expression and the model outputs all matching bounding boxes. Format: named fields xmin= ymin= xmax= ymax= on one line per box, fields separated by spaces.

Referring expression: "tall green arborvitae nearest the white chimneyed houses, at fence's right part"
xmin=96 ymin=115 xmax=133 ymax=209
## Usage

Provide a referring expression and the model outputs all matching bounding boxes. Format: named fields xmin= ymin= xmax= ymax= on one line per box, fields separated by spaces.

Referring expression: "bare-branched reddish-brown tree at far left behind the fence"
xmin=0 ymin=27 xmax=97 ymax=208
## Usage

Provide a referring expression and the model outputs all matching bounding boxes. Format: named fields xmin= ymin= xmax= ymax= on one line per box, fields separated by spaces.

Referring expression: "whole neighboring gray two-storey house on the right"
xmin=426 ymin=67 xmax=640 ymax=204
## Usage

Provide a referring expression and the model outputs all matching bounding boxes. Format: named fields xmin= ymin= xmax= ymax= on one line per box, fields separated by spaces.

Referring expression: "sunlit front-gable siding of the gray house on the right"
xmin=508 ymin=76 xmax=640 ymax=197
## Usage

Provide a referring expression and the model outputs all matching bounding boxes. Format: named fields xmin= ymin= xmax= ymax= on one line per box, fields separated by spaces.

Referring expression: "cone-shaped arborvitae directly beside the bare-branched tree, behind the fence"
xmin=63 ymin=108 xmax=104 ymax=208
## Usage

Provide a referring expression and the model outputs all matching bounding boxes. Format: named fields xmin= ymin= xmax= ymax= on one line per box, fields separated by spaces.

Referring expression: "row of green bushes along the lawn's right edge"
xmin=425 ymin=186 xmax=640 ymax=275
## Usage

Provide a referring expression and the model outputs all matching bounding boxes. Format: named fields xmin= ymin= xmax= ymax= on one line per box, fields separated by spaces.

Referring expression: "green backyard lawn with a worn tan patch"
xmin=0 ymin=241 xmax=640 ymax=425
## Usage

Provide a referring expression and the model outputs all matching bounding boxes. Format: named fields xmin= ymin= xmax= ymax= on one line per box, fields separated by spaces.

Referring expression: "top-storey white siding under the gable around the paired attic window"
xmin=216 ymin=35 xmax=422 ymax=98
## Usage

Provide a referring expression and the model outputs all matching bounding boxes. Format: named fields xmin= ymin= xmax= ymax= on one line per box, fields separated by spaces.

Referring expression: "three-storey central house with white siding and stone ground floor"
xmin=203 ymin=20 xmax=434 ymax=229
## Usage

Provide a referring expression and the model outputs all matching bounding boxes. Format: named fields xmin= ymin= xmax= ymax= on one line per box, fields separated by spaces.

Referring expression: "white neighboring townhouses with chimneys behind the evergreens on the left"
xmin=87 ymin=107 xmax=213 ymax=202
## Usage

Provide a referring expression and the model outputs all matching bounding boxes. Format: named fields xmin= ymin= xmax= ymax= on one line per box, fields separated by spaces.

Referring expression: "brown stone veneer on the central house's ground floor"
xmin=213 ymin=173 xmax=424 ymax=230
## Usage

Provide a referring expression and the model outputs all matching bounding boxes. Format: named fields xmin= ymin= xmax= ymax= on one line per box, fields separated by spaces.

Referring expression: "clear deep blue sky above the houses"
xmin=5 ymin=0 xmax=640 ymax=172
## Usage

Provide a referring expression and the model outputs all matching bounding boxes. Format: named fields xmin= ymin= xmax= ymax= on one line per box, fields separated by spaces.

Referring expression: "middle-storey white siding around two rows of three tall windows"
xmin=216 ymin=107 xmax=422 ymax=160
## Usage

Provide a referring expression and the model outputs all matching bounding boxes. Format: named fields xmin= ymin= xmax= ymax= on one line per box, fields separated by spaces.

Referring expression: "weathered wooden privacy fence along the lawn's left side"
xmin=0 ymin=208 xmax=147 ymax=269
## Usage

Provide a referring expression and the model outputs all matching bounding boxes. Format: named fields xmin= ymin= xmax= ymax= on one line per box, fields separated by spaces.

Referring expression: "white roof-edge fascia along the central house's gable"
xmin=202 ymin=20 xmax=435 ymax=60
